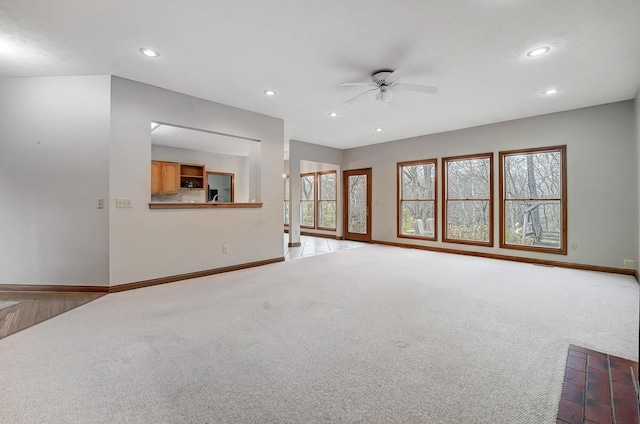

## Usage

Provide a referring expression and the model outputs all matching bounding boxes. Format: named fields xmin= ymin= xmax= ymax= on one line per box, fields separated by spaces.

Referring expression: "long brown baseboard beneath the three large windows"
xmin=371 ymin=240 xmax=638 ymax=279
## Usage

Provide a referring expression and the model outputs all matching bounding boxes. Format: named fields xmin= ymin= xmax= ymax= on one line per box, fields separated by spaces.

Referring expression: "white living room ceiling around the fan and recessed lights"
xmin=0 ymin=0 xmax=640 ymax=148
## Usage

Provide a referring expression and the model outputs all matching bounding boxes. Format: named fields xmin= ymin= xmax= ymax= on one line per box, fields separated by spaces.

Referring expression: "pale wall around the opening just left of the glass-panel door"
xmin=285 ymin=140 xmax=343 ymax=243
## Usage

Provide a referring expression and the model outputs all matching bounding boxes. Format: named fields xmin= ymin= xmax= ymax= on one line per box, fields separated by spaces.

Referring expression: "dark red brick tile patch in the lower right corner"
xmin=557 ymin=345 xmax=638 ymax=424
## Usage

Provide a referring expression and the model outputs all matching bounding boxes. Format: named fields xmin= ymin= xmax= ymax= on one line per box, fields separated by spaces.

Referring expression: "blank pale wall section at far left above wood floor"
xmin=0 ymin=76 xmax=111 ymax=285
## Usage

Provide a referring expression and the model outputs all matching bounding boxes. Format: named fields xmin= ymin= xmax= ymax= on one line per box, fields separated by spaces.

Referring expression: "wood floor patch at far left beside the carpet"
xmin=0 ymin=292 xmax=104 ymax=339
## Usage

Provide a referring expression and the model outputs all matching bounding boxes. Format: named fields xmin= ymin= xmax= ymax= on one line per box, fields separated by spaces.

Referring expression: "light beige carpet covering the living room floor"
xmin=0 ymin=245 xmax=638 ymax=424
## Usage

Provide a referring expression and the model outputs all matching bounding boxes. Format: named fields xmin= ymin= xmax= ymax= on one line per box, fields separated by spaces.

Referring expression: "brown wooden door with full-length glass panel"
xmin=344 ymin=168 xmax=371 ymax=241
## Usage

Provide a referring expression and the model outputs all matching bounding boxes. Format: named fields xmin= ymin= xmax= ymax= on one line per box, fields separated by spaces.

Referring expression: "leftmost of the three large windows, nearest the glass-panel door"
xmin=398 ymin=159 xmax=438 ymax=240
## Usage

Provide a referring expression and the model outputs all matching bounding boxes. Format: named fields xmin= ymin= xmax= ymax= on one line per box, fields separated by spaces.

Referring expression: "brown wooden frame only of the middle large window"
xmin=442 ymin=152 xmax=494 ymax=247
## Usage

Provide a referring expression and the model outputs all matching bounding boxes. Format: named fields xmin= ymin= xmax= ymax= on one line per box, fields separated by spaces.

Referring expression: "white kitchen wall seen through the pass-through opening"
xmin=151 ymin=145 xmax=249 ymax=203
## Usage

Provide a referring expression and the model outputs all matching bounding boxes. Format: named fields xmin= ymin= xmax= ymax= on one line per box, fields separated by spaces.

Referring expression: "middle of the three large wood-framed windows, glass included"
xmin=442 ymin=153 xmax=493 ymax=246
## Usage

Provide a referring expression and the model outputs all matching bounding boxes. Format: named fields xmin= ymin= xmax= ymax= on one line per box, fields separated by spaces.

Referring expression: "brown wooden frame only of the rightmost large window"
xmin=498 ymin=145 xmax=568 ymax=255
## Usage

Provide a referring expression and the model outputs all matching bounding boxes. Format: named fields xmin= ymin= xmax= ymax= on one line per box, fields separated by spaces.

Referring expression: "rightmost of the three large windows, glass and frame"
xmin=500 ymin=146 xmax=567 ymax=254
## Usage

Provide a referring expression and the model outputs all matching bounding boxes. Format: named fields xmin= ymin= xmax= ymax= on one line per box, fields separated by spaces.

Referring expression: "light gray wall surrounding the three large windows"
xmin=342 ymin=101 xmax=640 ymax=268
